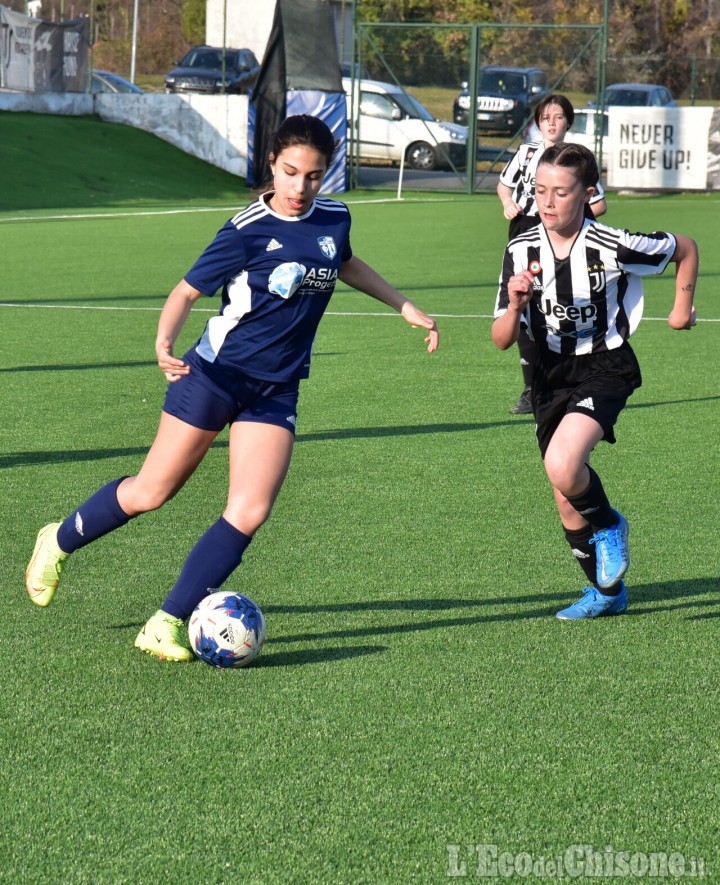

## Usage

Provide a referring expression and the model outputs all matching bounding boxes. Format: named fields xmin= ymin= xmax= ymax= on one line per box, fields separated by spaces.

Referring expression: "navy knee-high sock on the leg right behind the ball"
xmin=160 ymin=517 xmax=252 ymax=620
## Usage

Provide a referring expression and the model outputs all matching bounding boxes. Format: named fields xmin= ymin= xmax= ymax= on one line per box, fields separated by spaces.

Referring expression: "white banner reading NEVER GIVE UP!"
xmin=608 ymin=107 xmax=720 ymax=191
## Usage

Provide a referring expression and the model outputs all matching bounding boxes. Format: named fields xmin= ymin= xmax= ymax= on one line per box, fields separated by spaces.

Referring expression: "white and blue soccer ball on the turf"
xmin=188 ymin=591 xmax=265 ymax=667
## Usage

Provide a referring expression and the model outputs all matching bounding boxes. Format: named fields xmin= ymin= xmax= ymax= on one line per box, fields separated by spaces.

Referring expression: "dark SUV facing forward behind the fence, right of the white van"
xmin=453 ymin=65 xmax=548 ymax=134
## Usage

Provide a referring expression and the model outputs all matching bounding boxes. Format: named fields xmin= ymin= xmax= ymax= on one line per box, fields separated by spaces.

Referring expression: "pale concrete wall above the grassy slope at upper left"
xmin=0 ymin=92 xmax=248 ymax=177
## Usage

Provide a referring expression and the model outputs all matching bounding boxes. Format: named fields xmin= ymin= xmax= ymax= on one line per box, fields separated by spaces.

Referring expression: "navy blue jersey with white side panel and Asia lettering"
xmin=185 ymin=194 xmax=352 ymax=381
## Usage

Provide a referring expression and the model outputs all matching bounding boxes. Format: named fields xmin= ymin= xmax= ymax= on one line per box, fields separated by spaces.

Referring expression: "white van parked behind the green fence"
xmin=343 ymin=77 xmax=467 ymax=171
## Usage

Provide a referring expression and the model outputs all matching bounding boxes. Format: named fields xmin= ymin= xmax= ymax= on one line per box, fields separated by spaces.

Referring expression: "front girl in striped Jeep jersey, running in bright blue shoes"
xmin=492 ymin=144 xmax=698 ymax=620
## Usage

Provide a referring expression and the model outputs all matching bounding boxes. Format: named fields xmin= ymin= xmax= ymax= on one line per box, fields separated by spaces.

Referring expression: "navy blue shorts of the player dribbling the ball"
xmin=163 ymin=349 xmax=300 ymax=436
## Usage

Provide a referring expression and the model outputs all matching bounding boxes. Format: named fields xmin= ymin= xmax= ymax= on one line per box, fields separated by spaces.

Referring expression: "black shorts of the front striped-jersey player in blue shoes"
xmin=532 ymin=341 xmax=642 ymax=458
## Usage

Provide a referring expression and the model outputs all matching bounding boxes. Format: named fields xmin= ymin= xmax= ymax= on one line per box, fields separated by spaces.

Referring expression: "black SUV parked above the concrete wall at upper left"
xmin=165 ymin=46 xmax=260 ymax=95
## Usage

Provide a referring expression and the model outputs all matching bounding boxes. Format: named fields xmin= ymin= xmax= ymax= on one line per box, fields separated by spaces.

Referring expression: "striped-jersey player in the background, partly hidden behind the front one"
xmin=497 ymin=95 xmax=607 ymax=415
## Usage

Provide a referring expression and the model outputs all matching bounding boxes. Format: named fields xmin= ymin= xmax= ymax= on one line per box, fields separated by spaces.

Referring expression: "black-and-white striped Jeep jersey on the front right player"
xmin=495 ymin=219 xmax=676 ymax=356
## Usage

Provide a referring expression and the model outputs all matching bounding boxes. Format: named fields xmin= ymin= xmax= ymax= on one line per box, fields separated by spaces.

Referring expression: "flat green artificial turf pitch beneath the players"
xmin=0 ymin=114 xmax=720 ymax=885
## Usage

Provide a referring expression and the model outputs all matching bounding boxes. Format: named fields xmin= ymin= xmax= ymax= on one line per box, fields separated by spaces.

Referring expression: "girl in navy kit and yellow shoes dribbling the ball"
xmin=26 ymin=115 xmax=438 ymax=661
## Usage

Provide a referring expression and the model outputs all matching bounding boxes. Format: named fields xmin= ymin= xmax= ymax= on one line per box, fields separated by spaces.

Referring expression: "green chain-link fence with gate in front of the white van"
xmin=346 ymin=23 xmax=720 ymax=193
